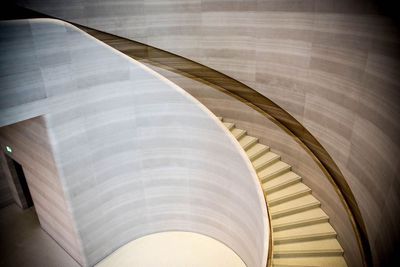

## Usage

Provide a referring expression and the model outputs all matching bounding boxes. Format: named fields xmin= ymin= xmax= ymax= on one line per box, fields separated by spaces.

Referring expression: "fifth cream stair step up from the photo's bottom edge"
xmin=270 ymin=194 xmax=321 ymax=219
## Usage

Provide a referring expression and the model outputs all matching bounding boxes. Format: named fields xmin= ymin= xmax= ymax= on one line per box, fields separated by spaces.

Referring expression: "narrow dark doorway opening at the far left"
xmin=6 ymin=155 xmax=33 ymax=209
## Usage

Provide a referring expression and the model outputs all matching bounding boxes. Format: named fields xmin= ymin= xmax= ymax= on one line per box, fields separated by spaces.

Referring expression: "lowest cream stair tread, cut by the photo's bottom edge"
xmin=272 ymin=256 xmax=347 ymax=267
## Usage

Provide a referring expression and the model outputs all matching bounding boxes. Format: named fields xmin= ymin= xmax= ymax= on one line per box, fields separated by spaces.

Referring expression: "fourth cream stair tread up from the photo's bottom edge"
xmin=272 ymin=208 xmax=329 ymax=227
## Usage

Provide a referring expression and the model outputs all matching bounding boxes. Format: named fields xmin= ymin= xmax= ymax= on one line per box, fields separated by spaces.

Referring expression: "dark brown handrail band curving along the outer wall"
xmin=77 ymin=25 xmax=371 ymax=264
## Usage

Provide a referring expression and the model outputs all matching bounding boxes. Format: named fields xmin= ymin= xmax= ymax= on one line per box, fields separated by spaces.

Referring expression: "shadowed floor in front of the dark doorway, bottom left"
xmin=0 ymin=204 xmax=80 ymax=267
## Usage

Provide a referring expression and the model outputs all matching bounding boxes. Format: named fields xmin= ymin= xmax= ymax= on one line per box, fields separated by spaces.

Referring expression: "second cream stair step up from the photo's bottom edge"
xmin=274 ymin=238 xmax=343 ymax=258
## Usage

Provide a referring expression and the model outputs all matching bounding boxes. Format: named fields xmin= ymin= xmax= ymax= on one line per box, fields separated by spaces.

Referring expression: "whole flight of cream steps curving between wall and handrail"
xmin=218 ymin=117 xmax=347 ymax=266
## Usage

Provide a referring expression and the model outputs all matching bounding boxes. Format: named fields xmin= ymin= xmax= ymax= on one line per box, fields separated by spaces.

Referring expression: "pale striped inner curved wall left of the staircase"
xmin=0 ymin=19 xmax=268 ymax=267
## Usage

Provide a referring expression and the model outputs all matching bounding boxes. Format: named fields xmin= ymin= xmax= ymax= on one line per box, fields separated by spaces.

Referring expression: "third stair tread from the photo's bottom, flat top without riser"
xmin=274 ymin=222 xmax=336 ymax=241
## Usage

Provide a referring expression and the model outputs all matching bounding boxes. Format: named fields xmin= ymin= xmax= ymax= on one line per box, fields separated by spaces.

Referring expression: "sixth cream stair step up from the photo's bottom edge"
xmin=266 ymin=183 xmax=311 ymax=207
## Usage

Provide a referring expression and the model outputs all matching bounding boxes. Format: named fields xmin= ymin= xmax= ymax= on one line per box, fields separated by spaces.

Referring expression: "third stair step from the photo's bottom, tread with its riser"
xmin=273 ymin=222 xmax=336 ymax=244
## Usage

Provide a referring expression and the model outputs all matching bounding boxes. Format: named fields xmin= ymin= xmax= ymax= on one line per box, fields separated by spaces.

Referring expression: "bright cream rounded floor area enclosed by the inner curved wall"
xmin=96 ymin=231 xmax=246 ymax=267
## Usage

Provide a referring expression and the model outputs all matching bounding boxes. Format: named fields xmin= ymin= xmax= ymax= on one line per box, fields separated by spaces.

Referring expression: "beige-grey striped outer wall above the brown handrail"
xmin=13 ymin=0 xmax=400 ymax=264
